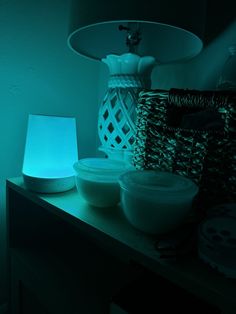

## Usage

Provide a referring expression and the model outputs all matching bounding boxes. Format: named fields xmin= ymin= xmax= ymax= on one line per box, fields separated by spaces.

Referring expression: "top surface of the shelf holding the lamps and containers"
xmin=7 ymin=177 xmax=236 ymax=313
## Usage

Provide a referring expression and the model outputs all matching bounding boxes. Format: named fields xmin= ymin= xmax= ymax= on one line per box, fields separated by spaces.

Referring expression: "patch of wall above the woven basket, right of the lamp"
xmin=150 ymin=17 xmax=236 ymax=89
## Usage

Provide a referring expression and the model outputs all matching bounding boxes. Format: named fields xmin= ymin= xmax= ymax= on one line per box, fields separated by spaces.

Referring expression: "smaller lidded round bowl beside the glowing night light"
xmin=74 ymin=158 xmax=131 ymax=207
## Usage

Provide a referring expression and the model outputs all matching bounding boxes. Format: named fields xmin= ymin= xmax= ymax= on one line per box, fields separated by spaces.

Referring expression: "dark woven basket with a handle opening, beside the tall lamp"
xmin=134 ymin=89 xmax=236 ymax=207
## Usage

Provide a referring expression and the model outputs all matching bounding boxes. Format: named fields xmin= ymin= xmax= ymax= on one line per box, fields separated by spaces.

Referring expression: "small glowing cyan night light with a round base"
xmin=22 ymin=114 xmax=78 ymax=193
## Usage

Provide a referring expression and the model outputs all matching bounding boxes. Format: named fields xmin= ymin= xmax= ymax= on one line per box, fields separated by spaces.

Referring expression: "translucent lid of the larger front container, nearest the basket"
xmin=119 ymin=170 xmax=198 ymax=197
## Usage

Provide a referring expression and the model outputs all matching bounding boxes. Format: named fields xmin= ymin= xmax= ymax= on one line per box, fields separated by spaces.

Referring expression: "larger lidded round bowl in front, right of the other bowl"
xmin=119 ymin=170 xmax=198 ymax=234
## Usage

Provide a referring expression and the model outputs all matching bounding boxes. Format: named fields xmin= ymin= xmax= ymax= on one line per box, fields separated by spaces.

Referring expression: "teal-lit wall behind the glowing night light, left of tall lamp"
xmin=0 ymin=0 xmax=99 ymax=304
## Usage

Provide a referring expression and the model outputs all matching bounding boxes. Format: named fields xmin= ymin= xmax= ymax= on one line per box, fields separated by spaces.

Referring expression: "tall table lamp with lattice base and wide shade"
xmin=68 ymin=0 xmax=205 ymax=161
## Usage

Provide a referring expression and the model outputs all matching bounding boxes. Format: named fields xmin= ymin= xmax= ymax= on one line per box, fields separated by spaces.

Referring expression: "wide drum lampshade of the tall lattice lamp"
xmin=68 ymin=0 xmax=206 ymax=64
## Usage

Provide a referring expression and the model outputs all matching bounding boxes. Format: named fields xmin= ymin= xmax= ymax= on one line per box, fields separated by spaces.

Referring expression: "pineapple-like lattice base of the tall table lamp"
xmin=98 ymin=53 xmax=155 ymax=161
